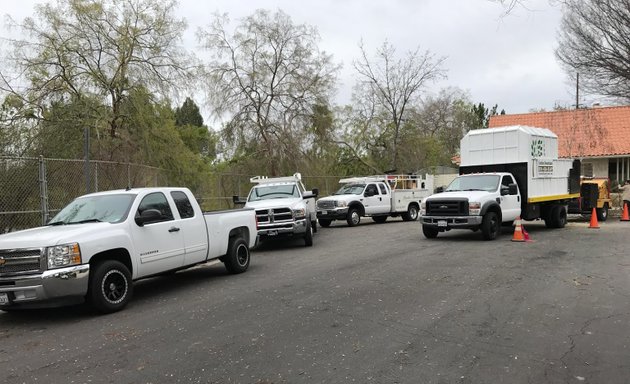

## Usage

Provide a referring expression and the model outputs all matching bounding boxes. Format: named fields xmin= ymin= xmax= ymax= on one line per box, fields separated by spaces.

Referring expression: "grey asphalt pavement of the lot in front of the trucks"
xmin=0 ymin=217 xmax=630 ymax=384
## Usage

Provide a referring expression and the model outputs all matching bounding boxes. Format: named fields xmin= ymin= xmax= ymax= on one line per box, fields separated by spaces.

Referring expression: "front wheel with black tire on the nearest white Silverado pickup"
xmin=88 ymin=260 xmax=133 ymax=313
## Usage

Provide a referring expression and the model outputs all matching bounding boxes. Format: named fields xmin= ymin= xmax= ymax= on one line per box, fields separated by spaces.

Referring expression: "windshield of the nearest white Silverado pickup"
xmin=48 ymin=194 xmax=136 ymax=225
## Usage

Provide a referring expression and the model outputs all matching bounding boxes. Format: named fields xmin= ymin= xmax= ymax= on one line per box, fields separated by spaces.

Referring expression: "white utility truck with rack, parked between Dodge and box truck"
xmin=317 ymin=175 xmax=433 ymax=227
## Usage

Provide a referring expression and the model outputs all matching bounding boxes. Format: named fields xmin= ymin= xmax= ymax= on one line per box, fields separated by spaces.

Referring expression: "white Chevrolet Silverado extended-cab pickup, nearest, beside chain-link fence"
xmin=0 ymin=188 xmax=256 ymax=313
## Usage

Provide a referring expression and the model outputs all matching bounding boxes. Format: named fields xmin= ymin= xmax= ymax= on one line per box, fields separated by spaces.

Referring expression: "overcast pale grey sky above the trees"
xmin=2 ymin=0 xmax=592 ymax=114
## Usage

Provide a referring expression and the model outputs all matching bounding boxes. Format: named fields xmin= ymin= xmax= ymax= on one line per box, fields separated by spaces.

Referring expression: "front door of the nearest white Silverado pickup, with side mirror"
xmin=131 ymin=192 xmax=185 ymax=277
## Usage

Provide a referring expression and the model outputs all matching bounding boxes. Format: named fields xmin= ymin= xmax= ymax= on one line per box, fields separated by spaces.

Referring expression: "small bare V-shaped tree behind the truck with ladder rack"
xmin=354 ymin=41 xmax=446 ymax=169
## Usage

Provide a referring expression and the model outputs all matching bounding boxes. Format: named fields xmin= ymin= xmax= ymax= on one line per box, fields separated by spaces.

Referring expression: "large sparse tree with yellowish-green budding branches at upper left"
xmin=0 ymin=0 xmax=190 ymax=137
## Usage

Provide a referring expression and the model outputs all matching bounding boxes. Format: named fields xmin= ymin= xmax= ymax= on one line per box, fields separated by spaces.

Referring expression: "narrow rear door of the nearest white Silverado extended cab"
xmin=171 ymin=191 xmax=208 ymax=265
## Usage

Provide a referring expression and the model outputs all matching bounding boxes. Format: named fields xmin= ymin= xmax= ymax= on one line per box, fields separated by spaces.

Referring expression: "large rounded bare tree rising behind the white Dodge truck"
xmin=198 ymin=10 xmax=338 ymax=175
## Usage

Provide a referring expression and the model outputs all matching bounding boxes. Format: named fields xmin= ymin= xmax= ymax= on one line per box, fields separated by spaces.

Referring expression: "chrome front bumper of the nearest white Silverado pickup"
xmin=0 ymin=264 xmax=90 ymax=309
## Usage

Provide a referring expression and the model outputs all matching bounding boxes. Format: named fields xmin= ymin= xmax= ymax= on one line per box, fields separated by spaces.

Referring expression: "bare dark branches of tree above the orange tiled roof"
xmin=556 ymin=0 xmax=630 ymax=101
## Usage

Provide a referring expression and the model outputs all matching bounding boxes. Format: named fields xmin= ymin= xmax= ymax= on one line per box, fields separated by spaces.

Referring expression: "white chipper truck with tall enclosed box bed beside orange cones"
xmin=420 ymin=126 xmax=580 ymax=240
